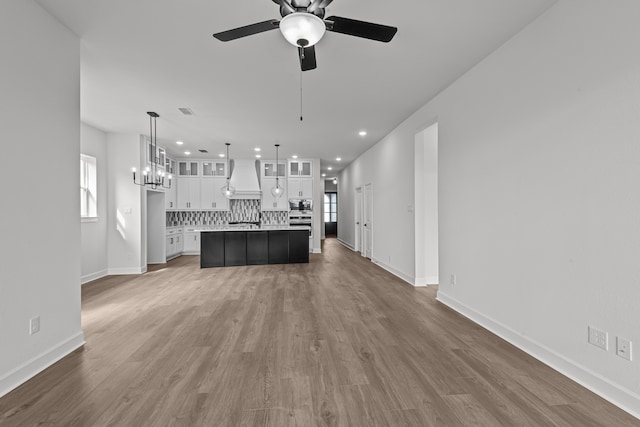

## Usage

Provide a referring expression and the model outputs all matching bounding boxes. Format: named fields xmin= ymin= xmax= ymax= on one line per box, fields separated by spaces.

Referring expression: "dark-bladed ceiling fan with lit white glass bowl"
xmin=213 ymin=0 xmax=398 ymax=71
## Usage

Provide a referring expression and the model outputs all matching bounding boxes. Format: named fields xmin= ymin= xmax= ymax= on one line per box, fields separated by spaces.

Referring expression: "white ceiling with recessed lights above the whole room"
xmin=37 ymin=0 xmax=556 ymax=176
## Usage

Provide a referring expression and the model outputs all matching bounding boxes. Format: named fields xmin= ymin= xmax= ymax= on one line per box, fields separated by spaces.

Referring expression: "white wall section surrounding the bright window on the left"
xmin=80 ymin=123 xmax=108 ymax=283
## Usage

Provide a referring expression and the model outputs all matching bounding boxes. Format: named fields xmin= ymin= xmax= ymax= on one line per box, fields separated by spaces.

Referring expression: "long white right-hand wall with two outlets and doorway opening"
xmin=339 ymin=0 xmax=640 ymax=416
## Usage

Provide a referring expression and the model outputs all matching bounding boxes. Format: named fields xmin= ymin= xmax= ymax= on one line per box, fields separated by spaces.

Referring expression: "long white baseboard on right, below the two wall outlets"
xmin=436 ymin=290 xmax=640 ymax=419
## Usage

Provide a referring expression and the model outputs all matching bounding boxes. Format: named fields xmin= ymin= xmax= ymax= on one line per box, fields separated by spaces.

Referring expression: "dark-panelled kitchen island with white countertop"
xmin=200 ymin=226 xmax=309 ymax=268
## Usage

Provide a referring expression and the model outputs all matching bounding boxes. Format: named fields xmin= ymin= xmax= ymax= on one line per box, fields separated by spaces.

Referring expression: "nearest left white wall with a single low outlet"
xmin=0 ymin=0 xmax=84 ymax=396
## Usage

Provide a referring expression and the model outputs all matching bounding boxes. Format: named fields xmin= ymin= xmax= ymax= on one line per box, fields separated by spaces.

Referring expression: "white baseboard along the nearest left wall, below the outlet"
xmin=0 ymin=331 xmax=84 ymax=397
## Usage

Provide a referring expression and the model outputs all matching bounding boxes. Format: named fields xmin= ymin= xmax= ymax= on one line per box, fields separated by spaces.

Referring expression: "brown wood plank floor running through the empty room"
xmin=0 ymin=239 xmax=640 ymax=427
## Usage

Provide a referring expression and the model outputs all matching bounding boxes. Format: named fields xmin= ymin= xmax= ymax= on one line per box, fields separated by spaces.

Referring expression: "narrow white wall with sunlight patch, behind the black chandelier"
xmin=107 ymin=133 xmax=147 ymax=274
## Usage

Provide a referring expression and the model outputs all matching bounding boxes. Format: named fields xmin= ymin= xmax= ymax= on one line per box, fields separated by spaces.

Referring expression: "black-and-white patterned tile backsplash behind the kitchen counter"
xmin=167 ymin=199 xmax=289 ymax=227
